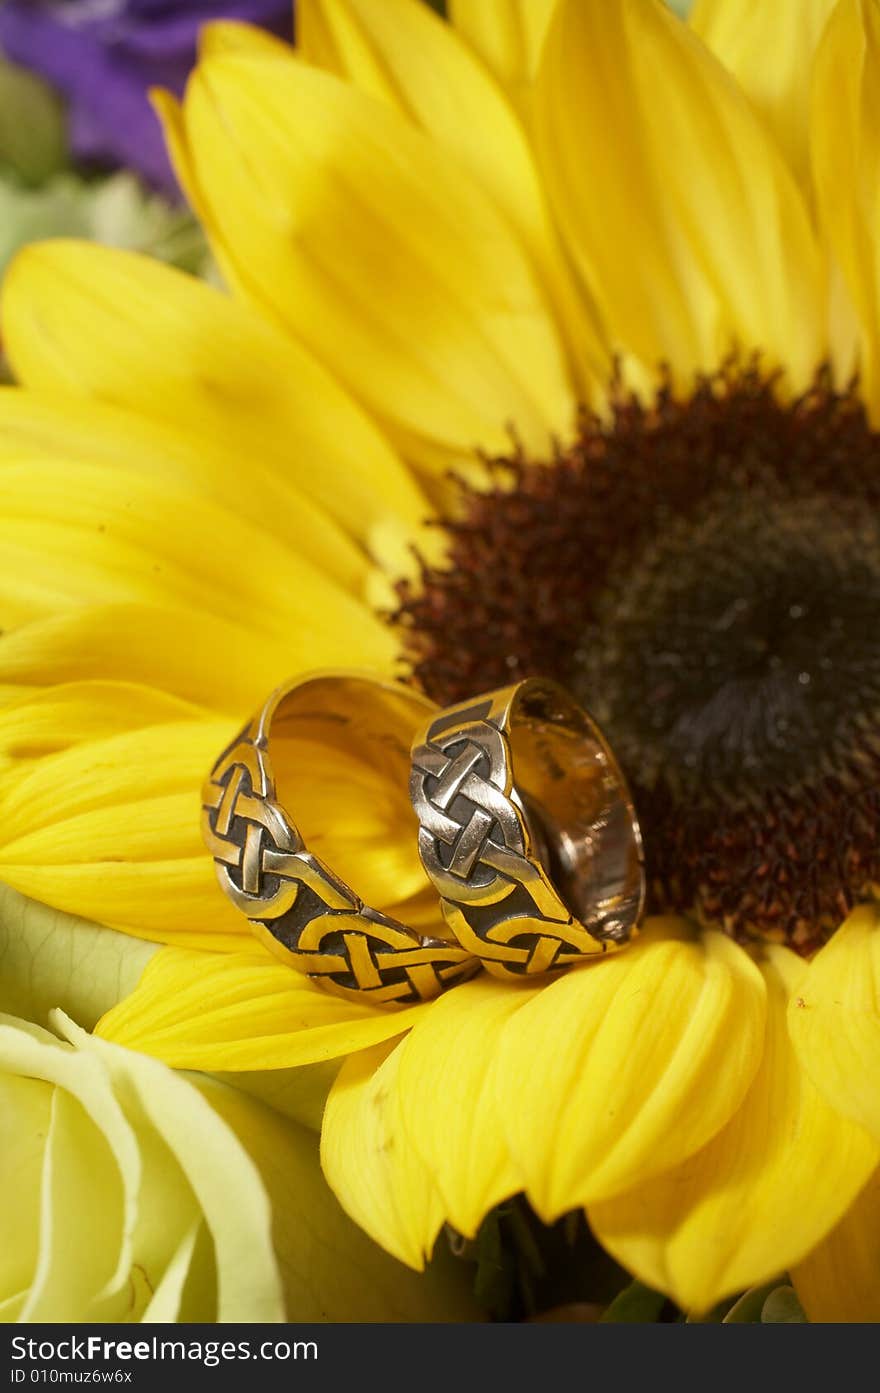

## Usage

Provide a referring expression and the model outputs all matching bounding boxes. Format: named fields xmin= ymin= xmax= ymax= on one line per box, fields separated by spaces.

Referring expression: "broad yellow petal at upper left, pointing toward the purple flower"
xmin=173 ymin=56 xmax=572 ymax=470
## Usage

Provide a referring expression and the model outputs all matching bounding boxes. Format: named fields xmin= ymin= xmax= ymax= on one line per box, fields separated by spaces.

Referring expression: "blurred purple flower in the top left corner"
xmin=0 ymin=0 xmax=292 ymax=191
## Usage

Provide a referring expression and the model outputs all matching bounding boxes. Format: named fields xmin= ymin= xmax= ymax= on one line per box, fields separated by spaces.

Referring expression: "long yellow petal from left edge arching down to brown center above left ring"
xmin=0 ymin=462 xmax=397 ymax=666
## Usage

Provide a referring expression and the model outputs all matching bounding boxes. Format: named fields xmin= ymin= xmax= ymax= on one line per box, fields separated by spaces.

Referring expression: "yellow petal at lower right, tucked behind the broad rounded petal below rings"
xmin=589 ymin=949 xmax=880 ymax=1311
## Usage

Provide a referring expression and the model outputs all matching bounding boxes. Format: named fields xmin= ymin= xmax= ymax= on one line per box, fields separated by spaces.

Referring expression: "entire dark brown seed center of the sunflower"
xmin=398 ymin=369 xmax=880 ymax=951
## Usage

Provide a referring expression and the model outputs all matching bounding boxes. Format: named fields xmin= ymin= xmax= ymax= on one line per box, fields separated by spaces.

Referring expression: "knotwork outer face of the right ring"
xmin=409 ymin=688 xmax=643 ymax=978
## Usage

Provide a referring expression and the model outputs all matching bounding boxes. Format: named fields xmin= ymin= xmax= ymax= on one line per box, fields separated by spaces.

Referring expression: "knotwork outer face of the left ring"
xmin=202 ymin=722 xmax=479 ymax=1006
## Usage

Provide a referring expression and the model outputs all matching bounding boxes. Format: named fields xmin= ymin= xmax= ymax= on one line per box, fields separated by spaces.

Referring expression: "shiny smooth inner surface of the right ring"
xmin=510 ymin=683 xmax=645 ymax=942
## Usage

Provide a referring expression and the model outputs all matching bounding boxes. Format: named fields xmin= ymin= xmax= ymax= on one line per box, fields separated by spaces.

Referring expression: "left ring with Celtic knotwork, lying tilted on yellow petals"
xmin=202 ymin=673 xmax=479 ymax=1006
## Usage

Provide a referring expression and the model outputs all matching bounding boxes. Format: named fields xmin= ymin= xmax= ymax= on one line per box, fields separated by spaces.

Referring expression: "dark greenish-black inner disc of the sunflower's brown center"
xmin=574 ymin=489 xmax=880 ymax=807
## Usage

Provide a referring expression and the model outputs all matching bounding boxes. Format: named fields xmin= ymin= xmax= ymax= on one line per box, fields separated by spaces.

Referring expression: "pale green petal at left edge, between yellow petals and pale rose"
xmin=0 ymin=885 xmax=157 ymax=1029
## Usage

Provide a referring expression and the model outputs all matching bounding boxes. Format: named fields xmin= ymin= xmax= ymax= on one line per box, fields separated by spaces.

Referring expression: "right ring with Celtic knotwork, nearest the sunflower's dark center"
xmin=409 ymin=678 xmax=645 ymax=976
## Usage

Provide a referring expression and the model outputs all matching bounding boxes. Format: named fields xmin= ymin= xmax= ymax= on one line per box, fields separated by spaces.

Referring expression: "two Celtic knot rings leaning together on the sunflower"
xmin=202 ymin=673 xmax=645 ymax=1006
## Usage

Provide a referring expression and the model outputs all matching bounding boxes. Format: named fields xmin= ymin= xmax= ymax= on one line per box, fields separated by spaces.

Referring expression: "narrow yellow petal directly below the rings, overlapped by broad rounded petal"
xmin=395 ymin=975 xmax=535 ymax=1237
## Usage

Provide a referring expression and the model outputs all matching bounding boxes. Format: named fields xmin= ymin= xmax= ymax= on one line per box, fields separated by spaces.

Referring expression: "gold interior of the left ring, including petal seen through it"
xmin=267 ymin=676 xmax=446 ymax=936
